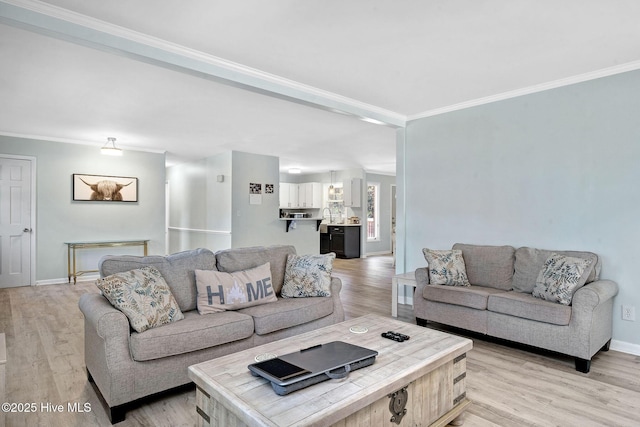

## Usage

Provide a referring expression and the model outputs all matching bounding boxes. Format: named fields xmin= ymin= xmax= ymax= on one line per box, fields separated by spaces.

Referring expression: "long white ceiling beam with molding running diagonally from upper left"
xmin=0 ymin=0 xmax=406 ymax=128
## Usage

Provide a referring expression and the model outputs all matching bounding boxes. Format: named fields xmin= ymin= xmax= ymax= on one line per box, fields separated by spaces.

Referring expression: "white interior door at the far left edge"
xmin=0 ymin=157 xmax=32 ymax=288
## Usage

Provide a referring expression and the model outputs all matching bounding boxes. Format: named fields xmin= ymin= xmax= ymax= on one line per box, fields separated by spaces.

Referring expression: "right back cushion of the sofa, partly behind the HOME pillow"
xmin=215 ymin=245 xmax=296 ymax=295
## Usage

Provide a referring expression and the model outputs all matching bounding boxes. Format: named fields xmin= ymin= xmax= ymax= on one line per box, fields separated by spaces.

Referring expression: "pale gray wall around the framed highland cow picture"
xmin=0 ymin=135 xmax=165 ymax=282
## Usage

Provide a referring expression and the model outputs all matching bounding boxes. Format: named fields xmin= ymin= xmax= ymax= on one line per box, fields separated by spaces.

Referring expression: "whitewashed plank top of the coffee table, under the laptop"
xmin=189 ymin=315 xmax=472 ymax=426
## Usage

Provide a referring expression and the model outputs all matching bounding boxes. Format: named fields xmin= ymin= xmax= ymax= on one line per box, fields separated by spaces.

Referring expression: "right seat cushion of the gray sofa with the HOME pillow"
xmin=238 ymin=297 xmax=333 ymax=335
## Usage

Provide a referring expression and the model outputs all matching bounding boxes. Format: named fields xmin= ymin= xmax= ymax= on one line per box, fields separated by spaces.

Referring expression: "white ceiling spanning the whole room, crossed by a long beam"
xmin=0 ymin=0 xmax=640 ymax=174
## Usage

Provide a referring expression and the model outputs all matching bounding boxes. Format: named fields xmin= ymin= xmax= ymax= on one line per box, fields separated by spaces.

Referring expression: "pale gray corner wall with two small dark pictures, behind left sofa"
xmin=167 ymin=151 xmax=320 ymax=254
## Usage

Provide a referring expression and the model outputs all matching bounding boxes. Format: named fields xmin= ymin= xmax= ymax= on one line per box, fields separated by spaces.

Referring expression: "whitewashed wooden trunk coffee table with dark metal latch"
xmin=189 ymin=315 xmax=472 ymax=426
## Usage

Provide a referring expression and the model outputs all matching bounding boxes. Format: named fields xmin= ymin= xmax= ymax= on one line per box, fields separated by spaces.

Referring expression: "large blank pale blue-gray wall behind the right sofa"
xmin=398 ymin=71 xmax=640 ymax=349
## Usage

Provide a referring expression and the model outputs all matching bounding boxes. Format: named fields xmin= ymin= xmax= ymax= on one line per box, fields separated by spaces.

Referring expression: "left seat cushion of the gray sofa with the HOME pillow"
xmin=130 ymin=310 xmax=253 ymax=362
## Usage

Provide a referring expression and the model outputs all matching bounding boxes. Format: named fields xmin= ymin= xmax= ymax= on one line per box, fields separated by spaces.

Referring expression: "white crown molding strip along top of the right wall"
xmin=407 ymin=61 xmax=640 ymax=122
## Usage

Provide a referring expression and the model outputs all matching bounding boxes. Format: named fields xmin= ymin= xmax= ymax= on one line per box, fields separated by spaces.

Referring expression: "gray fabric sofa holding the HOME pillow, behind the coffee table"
xmin=79 ymin=246 xmax=344 ymax=423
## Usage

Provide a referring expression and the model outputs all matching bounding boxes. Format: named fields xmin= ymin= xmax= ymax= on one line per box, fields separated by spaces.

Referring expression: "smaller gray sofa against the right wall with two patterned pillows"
xmin=414 ymin=243 xmax=618 ymax=373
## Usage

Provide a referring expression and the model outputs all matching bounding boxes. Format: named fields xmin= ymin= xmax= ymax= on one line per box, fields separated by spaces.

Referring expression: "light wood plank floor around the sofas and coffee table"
xmin=0 ymin=256 xmax=640 ymax=427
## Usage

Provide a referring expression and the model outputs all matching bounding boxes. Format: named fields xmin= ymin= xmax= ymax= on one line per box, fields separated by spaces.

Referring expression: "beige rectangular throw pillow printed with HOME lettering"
xmin=196 ymin=262 xmax=278 ymax=314
